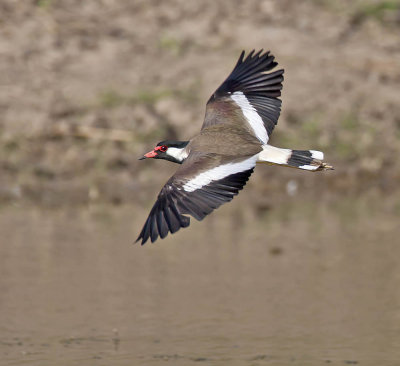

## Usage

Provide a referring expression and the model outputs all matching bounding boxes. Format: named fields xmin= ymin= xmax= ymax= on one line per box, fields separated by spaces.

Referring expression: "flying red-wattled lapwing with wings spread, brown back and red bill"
xmin=136 ymin=50 xmax=332 ymax=245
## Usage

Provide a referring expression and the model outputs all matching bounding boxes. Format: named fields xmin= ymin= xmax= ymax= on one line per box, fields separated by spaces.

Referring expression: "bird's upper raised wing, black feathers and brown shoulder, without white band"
xmin=203 ymin=50 xmax=284 ymax=136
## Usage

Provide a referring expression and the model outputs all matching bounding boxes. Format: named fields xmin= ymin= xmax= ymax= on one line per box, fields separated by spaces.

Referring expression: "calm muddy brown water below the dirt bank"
xmin=0 ymin=199 xmax=400 ymax=365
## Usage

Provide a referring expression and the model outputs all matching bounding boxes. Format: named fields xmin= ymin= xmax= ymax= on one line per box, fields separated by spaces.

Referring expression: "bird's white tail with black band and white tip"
xmin=257 ymin=145 xmax=333 ymax=171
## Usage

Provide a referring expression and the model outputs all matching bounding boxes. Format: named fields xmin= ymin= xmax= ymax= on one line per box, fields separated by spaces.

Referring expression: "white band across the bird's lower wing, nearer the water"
xmin=183 ymin=155 xmax=257 ymax=192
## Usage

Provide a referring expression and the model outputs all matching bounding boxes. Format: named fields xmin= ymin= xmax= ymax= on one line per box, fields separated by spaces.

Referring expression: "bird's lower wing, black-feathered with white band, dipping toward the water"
xmin=136 ymin=156 xmax=255 ymax=245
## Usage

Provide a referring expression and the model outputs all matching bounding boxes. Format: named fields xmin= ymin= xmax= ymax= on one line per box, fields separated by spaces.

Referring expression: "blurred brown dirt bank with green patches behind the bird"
xmin=0 ymin=0 xmax=400 ymax=209
